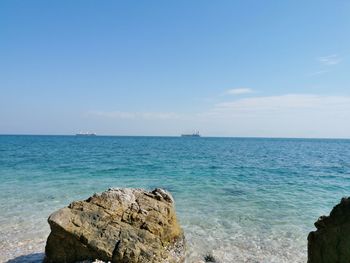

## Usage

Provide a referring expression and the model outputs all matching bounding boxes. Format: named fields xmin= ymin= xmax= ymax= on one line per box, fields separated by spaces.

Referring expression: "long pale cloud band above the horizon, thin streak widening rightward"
xmin=90 ymin=94 xmax=350 ymax=138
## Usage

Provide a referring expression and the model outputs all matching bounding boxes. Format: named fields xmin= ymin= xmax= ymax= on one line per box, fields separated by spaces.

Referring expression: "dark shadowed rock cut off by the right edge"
xmin=307 ymin=198 xmax=350 ymax=263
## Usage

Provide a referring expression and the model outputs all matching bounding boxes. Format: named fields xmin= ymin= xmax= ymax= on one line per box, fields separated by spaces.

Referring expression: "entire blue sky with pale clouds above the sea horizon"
xmin=0 ymin=0 xmax=350 ymax=138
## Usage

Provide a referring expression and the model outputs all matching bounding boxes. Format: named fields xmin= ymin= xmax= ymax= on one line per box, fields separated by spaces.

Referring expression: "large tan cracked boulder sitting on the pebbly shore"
xmin=45 ymin=188 xmax=184 ymax=263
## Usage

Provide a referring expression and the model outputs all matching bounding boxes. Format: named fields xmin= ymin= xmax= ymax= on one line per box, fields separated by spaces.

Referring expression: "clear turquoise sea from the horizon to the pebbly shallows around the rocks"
xmin=0 ymin=136 xmax=350 ymax=263
